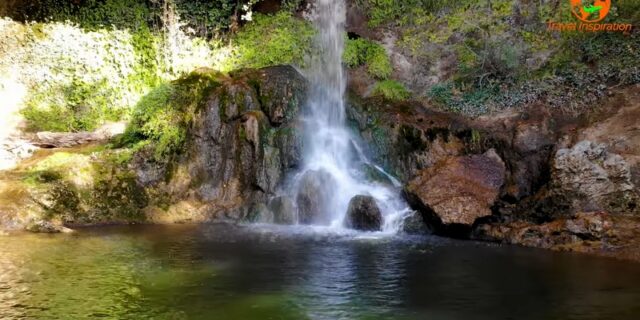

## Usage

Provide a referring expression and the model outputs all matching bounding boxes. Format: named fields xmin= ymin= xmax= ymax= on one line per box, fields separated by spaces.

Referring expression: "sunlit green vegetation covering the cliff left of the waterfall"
xmin=0 ymin=0 xmax=314 ymax=132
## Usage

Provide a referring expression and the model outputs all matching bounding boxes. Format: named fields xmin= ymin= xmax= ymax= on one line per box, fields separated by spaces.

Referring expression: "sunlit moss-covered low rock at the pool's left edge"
xmin=11 ymin=147 xmax=148 ymax=224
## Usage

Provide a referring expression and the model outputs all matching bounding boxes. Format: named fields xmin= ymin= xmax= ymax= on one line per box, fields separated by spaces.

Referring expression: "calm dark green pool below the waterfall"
xmin=0 ymin=225 xmax=640 ymax=319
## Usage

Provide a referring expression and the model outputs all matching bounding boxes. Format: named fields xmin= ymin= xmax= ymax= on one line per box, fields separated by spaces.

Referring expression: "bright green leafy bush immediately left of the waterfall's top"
xmin=233 ymin=12 xmax=315 ymax=68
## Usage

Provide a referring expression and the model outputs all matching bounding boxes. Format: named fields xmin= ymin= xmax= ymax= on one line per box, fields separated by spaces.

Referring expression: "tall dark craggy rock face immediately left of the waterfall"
xmin=150 ymin=66 xmax=307 ymax=220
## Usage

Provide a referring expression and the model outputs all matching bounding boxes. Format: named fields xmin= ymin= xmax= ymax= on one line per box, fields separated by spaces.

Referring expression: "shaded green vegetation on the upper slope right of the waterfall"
xmin=358 ymin=0 xmax=640 ymax=115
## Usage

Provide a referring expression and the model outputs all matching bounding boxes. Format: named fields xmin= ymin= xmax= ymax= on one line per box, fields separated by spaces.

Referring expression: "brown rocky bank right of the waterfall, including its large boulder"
xmin=349 ymin=85 xmax=640 ymax=259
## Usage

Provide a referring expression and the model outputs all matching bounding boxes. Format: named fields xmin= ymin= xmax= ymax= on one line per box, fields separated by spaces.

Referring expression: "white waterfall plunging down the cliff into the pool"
xmin=294 ymin=0 xmax=409 ymax=232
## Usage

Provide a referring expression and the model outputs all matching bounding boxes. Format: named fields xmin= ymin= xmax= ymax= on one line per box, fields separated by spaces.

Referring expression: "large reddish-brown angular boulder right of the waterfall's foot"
xmin=405 ymin=150 xmax=505 ymax=231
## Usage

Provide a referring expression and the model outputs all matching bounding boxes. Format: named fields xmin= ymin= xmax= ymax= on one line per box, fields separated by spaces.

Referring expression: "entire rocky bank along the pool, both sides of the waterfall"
xmin=0 ymin=67 xmax=640 ymax=259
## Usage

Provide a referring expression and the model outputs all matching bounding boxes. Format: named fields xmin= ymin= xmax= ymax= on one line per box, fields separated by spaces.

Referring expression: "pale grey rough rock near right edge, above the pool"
xmin=551 ymin=141 xmax=637 ymax=213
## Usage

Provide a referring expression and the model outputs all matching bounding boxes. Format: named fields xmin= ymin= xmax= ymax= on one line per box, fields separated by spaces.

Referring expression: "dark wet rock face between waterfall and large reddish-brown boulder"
xmin=347 ymin=94 xmax=466 ymax=181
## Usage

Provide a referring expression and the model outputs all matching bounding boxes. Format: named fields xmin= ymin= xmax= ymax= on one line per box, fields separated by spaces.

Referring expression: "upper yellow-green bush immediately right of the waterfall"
xmin=343 ymin=38 xmax=393 ymax=79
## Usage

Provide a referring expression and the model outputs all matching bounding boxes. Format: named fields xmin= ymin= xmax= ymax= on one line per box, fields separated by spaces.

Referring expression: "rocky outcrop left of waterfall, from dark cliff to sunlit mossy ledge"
xmin=0 ymin=66 xmax=307 ymax=231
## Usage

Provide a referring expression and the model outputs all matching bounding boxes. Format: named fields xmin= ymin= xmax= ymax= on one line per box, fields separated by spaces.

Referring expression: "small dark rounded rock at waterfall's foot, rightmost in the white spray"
xmin=344 ymin=195 xmax=382 ymax=231
